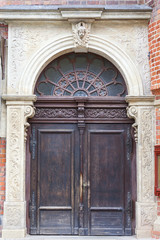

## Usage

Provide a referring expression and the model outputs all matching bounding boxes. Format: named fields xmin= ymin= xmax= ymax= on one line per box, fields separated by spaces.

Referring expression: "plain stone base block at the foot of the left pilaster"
xmin=2 ymin=228 xmax=27 ymax=239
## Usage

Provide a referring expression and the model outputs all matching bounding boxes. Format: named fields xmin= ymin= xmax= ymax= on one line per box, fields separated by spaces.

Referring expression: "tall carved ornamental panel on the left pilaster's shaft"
xmin=7 ymin=108 xmax=21 ymax=201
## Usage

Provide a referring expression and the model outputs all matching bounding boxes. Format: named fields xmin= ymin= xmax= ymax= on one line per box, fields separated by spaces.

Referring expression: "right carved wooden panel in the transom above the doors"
xmin=85 ymin=108 xmax=127 ymax=118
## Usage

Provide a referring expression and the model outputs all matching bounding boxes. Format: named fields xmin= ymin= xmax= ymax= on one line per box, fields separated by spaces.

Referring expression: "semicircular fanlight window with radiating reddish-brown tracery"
xmin=35 ymin=53 xmax=127 ymax=97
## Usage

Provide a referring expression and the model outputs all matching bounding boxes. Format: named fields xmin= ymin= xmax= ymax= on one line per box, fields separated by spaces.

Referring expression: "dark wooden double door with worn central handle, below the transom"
xmin=30 ymin=113 xmax=132 ymax=235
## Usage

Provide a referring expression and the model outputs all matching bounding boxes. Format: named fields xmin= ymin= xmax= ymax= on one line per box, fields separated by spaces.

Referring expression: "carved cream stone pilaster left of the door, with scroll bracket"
xmin=2 ymin=96 xmax=34 ymax=238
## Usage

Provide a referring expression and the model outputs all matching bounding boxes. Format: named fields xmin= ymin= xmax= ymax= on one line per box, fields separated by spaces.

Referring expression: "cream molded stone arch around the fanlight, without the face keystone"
xmin=19 ymin=35 xmax=143 ymax=96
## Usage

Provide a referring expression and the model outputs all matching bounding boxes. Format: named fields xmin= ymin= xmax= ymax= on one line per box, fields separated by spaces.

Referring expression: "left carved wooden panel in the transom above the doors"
xmin=35 ymin=108 xmax=77 ymax=118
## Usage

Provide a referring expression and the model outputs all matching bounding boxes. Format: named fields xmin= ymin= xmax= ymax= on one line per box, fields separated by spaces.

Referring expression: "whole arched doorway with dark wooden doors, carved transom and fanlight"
xmin=30 ymin=53 xmax=135 ymax=235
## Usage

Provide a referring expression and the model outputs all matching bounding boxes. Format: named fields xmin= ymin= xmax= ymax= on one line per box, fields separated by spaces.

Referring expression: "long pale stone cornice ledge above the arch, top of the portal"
xmin=0 ymin=5 xmax=152 ymax=21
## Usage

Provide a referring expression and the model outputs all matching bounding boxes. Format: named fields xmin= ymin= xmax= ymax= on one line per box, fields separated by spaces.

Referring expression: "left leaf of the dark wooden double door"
xmin=29 ymin=124 xmax=79 ymax=234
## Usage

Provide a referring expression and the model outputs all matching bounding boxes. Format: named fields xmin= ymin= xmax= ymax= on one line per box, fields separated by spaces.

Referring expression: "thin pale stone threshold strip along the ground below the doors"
xmin=0 ymin=235 xmax=153 ymax=240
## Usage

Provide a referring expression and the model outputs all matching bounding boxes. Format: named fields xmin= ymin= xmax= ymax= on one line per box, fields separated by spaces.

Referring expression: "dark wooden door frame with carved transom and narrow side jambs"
xmin=26 ymin=97 xmax=137 ymax=234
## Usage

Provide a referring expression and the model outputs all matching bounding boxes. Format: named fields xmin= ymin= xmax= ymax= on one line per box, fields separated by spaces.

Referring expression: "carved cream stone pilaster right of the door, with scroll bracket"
xmin=128 ymin=95 xmax=156 ymax=238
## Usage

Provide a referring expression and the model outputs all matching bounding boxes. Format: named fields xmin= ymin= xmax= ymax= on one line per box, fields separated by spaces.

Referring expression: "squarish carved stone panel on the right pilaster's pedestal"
xmin=141 ymin=206 xmax=156 ymax=226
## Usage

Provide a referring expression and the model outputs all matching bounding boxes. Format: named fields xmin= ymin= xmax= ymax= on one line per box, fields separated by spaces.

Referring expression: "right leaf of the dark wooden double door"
xmin=87 ymin=124 xmax=130 ymax=235
